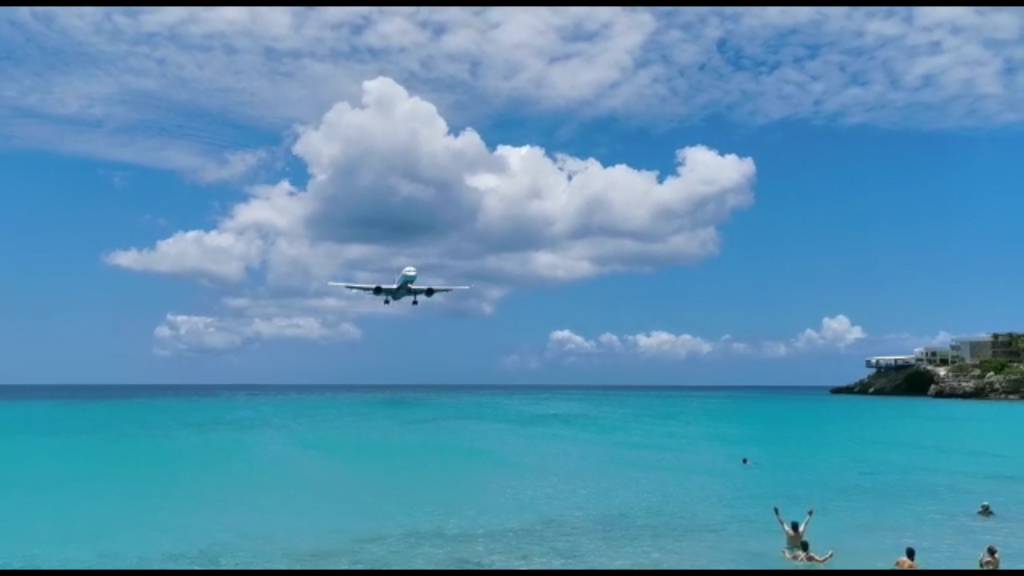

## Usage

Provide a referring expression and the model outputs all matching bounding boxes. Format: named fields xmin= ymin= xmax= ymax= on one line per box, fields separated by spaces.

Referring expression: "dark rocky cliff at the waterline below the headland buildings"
xmin=829 ymin=366 xmax=1024 ymax=400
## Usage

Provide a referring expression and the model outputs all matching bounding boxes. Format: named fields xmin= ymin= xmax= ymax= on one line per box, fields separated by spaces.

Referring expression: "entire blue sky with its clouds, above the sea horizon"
xmin=0 ymin=8 xmax=1024 ymax=385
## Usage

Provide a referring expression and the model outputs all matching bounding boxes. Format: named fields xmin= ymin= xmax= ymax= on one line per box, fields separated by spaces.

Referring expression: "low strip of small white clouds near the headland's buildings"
xmin=528 ymin=314 xmax=921 ymax=367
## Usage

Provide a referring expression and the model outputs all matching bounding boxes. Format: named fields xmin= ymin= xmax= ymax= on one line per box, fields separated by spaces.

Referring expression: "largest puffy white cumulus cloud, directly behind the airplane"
xmin=104 ymin=78 xmax=756 ymax=350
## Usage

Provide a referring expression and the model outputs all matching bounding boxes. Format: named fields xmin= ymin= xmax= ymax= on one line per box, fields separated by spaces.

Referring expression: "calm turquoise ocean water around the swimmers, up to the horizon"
xmin=0 ymin=387 xmax=1024 ymax=569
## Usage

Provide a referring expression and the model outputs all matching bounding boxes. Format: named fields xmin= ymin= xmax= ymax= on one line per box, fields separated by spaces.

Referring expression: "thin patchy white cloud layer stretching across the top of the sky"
xmin=0 ymin=6 xmax=1024 ymax=178
